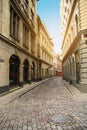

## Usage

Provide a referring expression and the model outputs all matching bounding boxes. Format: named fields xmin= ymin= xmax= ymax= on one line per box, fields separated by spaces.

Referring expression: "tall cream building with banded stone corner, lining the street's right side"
xmin=60 ymin=0 xmax=87 ymax=92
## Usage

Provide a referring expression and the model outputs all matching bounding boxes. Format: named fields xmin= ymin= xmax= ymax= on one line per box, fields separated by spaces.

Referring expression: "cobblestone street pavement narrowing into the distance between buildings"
xmin=0 ymin=77 xmax=87 ymax=130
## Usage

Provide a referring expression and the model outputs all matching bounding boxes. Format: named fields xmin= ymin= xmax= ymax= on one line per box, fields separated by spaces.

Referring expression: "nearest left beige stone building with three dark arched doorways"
xmin=0 ymin=0 xmax=37 ymax=93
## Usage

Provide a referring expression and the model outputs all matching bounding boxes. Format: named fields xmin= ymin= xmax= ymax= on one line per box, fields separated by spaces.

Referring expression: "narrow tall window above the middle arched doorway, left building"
xmin=23 ymin=25 xmax=28 ymax=49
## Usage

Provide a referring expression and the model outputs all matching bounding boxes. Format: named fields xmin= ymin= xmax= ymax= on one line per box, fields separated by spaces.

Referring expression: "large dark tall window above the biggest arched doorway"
xmin=10 ymin=7 xmax=19 ymax=39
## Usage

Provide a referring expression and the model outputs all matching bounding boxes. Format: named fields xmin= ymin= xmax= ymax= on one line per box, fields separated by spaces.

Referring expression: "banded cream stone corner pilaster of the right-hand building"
xmin=80 ymin=40 xmax=87 ymax=92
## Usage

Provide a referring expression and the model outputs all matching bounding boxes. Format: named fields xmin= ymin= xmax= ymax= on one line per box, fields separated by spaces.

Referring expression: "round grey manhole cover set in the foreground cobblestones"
xmin=48 ymin=114 xmax=75 ymax=125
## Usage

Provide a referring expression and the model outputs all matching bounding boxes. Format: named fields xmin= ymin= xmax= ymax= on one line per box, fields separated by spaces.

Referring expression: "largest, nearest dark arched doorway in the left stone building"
xmin=9 ymin=55 xmax=20 ymax=85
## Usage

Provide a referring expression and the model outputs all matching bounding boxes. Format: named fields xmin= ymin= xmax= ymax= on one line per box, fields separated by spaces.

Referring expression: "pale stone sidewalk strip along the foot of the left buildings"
xmin=0 ymin=78 xmax=49 ymax=106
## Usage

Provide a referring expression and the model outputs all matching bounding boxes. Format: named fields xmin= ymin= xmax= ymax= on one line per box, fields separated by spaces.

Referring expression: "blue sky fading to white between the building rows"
xmin=37 ymin=0 xmax=61 ymax=53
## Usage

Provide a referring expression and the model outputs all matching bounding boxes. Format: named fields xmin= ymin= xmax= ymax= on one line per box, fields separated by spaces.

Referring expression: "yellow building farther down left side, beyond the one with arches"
xmin=37 ymin=16 xmax=54 ymax=79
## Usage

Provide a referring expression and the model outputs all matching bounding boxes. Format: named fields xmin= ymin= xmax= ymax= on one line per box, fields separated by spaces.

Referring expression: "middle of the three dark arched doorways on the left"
xmin=23 ymin=60 xmax=29 ymax=82
